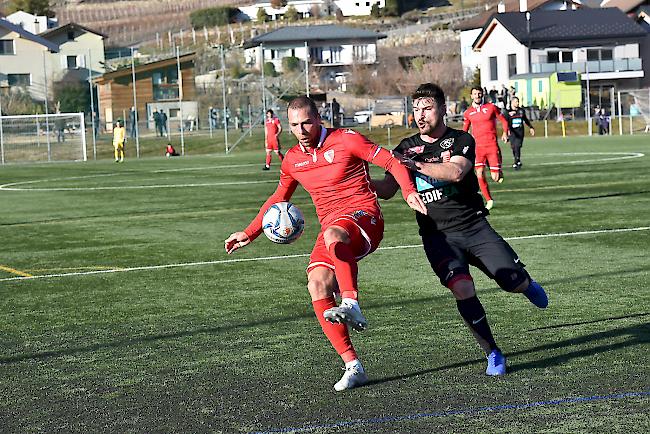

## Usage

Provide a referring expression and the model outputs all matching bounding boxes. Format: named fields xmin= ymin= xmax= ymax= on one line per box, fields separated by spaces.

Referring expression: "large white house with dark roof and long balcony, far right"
xmin=473 ymin=8 xmax=650 ymax=107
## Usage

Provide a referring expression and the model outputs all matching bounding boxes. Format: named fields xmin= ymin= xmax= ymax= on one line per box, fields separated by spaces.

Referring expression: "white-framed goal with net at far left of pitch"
xmin=0 ymin=113 xmax=86 ymax=164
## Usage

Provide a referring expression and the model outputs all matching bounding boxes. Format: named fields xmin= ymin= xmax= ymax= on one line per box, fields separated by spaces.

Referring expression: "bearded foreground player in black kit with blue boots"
xmin=373 ymin=83 xmax=548 ymax=375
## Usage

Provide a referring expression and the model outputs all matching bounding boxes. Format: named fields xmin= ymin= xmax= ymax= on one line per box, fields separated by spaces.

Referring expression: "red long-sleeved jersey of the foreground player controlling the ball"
xmin=244 ymin=127 xmax=416 ymax=241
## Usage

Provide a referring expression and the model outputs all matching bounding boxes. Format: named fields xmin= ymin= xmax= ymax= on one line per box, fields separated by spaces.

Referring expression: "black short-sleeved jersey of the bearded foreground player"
xmin=394 ymin=128 xmax=488 ymax=235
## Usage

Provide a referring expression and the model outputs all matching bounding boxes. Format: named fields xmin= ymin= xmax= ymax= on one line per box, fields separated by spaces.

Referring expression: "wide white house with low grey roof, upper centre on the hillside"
xmin=244 ymin=24 xmax=386 ymax=88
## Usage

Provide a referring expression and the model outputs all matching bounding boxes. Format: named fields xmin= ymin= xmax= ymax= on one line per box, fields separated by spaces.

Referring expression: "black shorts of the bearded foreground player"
xmin=422 ymin=218 xmax=528 ymax=291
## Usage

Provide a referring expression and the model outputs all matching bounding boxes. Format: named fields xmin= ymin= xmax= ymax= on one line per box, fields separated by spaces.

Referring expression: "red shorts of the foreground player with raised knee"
xmin=307 ymin=211 xmax=384 ymax=273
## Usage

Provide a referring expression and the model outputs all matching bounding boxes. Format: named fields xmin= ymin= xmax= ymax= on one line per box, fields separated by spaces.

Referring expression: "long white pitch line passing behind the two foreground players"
xmin=0 ymin=226 xmax=650 ymax=282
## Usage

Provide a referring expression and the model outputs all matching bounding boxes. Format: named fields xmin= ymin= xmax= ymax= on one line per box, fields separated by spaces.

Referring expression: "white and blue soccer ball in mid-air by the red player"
xmin=262 ymin=202 xmax=305 ymax=244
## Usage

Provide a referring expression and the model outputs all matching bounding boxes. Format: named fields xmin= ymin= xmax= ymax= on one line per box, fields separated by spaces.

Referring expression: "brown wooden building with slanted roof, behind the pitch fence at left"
xmin=93 ymin=53 xmax=198 ymax=131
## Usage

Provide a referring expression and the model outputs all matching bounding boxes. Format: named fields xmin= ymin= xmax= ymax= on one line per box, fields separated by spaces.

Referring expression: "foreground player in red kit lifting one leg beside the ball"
xmin=225 ymin=96 xmax=426 ymax=391
